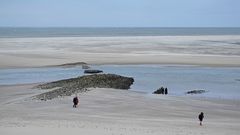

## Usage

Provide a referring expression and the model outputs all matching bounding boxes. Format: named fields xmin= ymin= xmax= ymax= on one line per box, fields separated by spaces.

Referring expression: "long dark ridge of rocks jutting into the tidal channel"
xmin=35 ymin=74 xmax=134 ymax=100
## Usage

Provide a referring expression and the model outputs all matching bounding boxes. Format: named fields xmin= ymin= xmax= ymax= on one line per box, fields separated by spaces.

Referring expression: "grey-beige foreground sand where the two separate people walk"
xmin=0 ymin=85 xmax=240 ymax=135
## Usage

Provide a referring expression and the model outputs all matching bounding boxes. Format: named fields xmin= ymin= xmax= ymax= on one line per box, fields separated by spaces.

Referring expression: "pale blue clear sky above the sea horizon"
xmin=0 ymin=0 xmax=240 ymax=27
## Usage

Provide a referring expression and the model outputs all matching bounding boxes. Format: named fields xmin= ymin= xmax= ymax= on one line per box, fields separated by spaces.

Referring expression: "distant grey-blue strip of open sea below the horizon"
xmin=0 ymin=27 xmax=240 ymax=38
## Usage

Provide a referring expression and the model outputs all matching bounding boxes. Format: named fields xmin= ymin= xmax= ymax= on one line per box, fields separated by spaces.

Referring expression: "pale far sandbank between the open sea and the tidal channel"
xmin=0 ymin=36 xmax=240 ymax=68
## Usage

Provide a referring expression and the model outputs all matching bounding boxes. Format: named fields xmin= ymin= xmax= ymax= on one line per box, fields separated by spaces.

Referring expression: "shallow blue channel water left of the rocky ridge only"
xmin=0 ymin=67 xmax=83 ymax=85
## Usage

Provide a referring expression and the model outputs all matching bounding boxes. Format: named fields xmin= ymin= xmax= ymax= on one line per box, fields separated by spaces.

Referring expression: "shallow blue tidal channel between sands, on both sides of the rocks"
xmin=0 ymin=65 xmax=240 ymax=99
